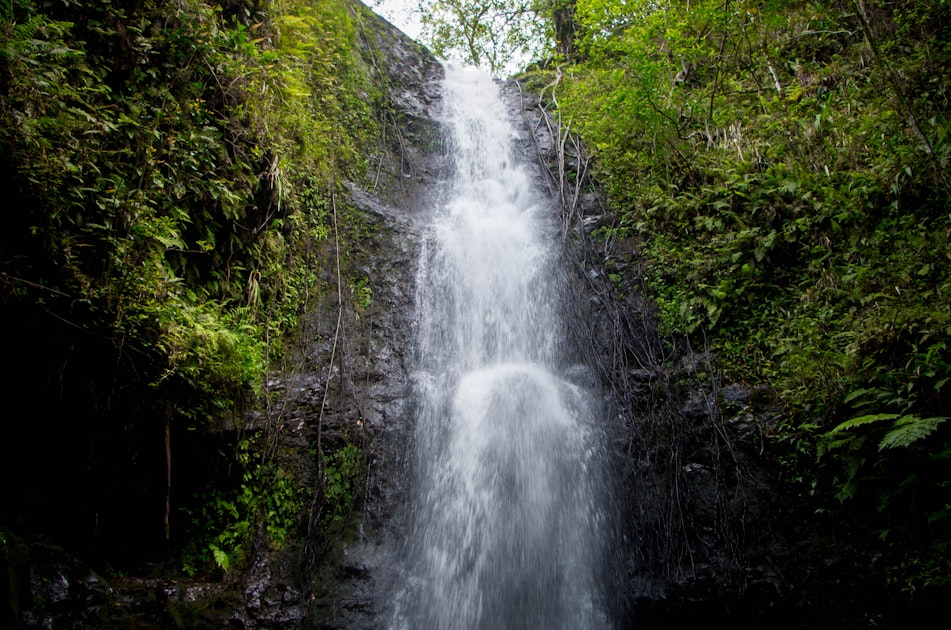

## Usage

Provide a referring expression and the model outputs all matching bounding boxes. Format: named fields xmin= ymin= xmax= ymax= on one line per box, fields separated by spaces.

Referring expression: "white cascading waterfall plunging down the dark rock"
xmin=392 ymin=67 xmax=611 ymax=629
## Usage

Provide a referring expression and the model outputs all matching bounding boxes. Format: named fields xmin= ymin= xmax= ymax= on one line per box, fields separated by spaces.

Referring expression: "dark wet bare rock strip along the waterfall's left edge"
xmin=284 ymin=7 xmax=450 ymax=630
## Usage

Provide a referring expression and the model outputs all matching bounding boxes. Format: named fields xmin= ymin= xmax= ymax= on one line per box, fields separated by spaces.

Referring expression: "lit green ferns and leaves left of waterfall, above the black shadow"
xmin=0 ymin=0 xmax=384 ymax=418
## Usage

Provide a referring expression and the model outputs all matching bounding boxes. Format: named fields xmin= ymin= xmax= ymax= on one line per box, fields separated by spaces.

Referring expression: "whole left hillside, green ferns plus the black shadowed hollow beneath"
xmin=0 ymin=0 xmax=383 ymax=588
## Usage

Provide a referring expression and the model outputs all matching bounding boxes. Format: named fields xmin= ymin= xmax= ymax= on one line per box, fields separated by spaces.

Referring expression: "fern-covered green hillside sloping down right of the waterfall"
xmin=548 ymin=0 xmax=951 ymax=601
